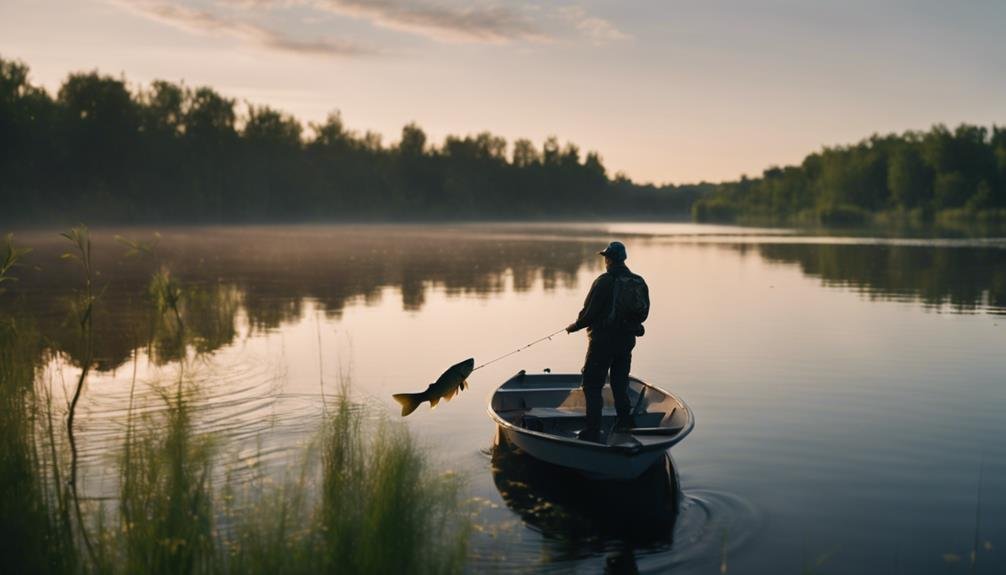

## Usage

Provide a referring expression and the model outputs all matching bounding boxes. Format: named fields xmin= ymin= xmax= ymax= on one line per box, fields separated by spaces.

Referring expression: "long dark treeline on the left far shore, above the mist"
xmin=0 ymin=58 xmax=712 ymax=223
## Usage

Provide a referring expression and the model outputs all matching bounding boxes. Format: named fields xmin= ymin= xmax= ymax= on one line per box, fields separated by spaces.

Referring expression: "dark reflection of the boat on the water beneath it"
xmin=492 ymin=441 xmax=680 ymax=573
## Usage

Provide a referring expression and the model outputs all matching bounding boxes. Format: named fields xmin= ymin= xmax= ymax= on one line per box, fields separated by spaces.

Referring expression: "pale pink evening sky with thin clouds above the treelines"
xmin=0 ymin=0 xmax=1006 ymax=183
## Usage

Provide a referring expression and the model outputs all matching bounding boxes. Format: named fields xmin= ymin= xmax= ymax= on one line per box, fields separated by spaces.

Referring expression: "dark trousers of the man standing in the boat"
xmin=582 ymin=331 xmax=636 ymax=434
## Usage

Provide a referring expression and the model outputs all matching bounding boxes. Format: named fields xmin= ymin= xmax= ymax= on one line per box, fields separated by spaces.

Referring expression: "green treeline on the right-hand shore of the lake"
xmin=692 ymin=125 xmax=1006 ymax=224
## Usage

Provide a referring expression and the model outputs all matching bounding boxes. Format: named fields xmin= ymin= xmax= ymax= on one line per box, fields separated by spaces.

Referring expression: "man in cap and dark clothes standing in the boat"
xmin=566 ymin=241 xmax=650 ymax=442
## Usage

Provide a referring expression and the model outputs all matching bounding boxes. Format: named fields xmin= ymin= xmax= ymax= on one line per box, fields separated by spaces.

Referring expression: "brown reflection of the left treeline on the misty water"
xmin=2 ymin=226 xmax=597 ymax=370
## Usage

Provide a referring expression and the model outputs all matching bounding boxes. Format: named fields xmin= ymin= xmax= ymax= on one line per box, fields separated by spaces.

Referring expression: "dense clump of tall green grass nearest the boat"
xmin=320 ymin=393 xmax=468 ymax=573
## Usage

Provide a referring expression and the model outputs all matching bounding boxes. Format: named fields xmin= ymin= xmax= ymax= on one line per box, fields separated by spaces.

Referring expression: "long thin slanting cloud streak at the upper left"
xmin=114 ymin=0 xmax=376 ymax=56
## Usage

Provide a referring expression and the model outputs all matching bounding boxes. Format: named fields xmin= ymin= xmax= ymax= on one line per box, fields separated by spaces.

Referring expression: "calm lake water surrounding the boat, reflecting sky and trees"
xmin=8 ymin=223 xmax=1006 ymax=573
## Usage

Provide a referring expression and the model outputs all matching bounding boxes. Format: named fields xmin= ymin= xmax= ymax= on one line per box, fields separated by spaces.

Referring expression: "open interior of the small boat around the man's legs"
xmin=491 ymin=372 xmax=688 ymax=445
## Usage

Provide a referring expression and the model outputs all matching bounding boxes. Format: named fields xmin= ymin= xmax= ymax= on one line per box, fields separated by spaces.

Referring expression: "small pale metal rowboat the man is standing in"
xmin=489 ymin=370 xmax=695 ymax=480
